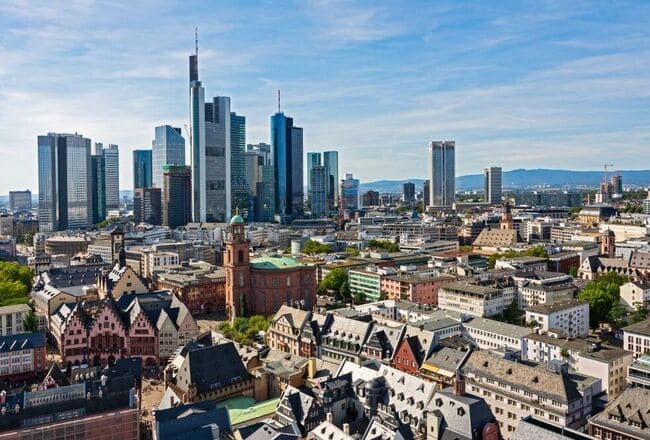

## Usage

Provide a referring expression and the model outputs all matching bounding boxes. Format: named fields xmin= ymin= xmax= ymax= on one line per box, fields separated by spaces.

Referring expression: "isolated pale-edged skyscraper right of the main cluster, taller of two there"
xmin=428 ymin=141 xmax=456 ymax=207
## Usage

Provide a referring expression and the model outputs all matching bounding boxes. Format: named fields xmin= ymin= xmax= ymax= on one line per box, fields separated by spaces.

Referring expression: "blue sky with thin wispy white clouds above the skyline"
xmin=0 ymin=0 xmax=650 ymax=194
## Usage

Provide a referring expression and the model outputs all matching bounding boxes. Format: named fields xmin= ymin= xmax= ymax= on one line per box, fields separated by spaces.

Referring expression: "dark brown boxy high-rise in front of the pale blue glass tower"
xmin=161 ymin=165 xmax=192 ymax=229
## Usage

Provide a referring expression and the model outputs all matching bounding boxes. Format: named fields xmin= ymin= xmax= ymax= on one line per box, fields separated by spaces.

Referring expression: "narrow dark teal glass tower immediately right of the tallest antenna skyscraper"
xmin=230 ymin=112 xmax=253 ymax=220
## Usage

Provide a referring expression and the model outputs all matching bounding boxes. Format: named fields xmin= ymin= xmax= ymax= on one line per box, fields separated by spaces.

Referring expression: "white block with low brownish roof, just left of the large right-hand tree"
xmin=526 ymin=298 xmax=589 ymax=338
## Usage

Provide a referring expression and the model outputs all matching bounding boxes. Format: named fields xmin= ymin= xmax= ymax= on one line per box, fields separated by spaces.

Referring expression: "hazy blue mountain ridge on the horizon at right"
xmin=360 ymin=168 xmax=650 ymax=192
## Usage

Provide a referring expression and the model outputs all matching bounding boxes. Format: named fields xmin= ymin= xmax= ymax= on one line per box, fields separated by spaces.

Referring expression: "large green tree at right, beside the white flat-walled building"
xmin=578 ymin=272 xmax=625 ymax=328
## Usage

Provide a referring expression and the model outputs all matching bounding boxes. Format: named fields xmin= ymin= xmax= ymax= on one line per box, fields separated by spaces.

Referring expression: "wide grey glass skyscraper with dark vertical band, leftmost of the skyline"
xmin=38 ymin=133 xmax=92 ymax=232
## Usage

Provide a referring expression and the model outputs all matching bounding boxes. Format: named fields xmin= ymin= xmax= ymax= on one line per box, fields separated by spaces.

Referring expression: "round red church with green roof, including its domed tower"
xmin=224 ymin=215 xmax=316 ymax=319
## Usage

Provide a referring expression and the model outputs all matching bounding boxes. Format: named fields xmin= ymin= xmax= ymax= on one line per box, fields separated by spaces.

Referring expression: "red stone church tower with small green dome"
xmin=223 ymin=214 xmax=252 ymax=321
